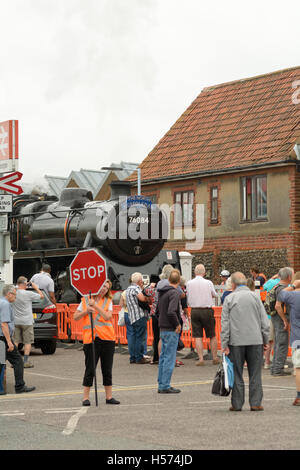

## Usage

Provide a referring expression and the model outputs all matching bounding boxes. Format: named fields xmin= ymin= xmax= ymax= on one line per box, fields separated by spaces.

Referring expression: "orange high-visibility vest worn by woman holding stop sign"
xmin=81 ymin=297 xmax=116 ymax=344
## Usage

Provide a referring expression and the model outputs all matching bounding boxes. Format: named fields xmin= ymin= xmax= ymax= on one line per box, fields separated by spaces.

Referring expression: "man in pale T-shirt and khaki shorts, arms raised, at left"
xmin=12 ymin=276 xmax=44 ymax=368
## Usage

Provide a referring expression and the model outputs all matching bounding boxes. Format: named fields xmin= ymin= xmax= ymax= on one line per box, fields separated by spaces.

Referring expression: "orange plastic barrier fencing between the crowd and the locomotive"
xmin=57 ymin=304 xmax=292 ymax=356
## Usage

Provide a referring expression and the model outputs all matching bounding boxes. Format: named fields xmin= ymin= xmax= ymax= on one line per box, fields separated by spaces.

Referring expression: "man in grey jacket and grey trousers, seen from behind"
xmin=221 ymin=272 xmax=269 ymax=411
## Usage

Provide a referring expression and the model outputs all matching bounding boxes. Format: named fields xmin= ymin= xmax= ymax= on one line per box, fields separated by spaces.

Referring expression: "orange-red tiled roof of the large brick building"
xmin=136 ymin=67 xmax=300 ymax=182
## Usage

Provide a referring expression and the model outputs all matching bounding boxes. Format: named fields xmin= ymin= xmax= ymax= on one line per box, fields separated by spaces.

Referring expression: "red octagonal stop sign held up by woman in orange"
xmin=70 ymin=249 xmax=107 ymax=296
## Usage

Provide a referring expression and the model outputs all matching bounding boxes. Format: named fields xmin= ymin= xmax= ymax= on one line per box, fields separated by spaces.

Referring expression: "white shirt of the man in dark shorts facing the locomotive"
xmin=186 ymin=276 xmax=217 ymax=308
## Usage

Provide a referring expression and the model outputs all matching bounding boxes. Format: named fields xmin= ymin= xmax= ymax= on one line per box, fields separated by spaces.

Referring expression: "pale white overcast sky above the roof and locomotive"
xmin=0 ymin=0 xmax=300 ymax=187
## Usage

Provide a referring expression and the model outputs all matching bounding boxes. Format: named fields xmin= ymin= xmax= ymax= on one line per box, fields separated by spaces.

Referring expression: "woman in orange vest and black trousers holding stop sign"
xmin=74 ymin=279 xmax=120 ymax=406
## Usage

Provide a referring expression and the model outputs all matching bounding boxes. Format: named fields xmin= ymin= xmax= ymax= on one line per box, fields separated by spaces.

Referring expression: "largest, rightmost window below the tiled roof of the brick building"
xmin=241 ymin=175 xmax=268 ymax=222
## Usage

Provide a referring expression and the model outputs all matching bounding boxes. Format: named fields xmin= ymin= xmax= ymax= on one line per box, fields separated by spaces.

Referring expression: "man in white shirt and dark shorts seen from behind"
xmin=186 ymin=264 xmax=220 ymax=366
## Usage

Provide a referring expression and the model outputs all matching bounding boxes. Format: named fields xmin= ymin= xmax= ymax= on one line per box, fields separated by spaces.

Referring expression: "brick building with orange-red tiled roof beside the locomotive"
xmin=131 ymin=67 xmax=300 ymax=281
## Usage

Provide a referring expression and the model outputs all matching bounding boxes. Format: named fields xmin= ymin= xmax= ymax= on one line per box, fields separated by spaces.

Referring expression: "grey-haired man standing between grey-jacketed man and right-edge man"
xmin=270 ymin=267 xmax=294 ymax=377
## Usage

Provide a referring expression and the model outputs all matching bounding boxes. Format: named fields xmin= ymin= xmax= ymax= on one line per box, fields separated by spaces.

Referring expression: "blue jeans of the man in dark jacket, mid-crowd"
xmin=157 ymin=331 xmax=179 ymax=390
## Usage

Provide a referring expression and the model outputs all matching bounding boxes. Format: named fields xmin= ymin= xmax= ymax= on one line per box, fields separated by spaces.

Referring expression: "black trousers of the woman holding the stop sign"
xmin=82 ymin=337 xmax=115 ymax=387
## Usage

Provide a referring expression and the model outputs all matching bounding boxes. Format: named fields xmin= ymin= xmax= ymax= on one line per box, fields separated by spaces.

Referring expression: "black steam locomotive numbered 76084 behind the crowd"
xmin=10 ymin=181 xmax=180 ymax=303
